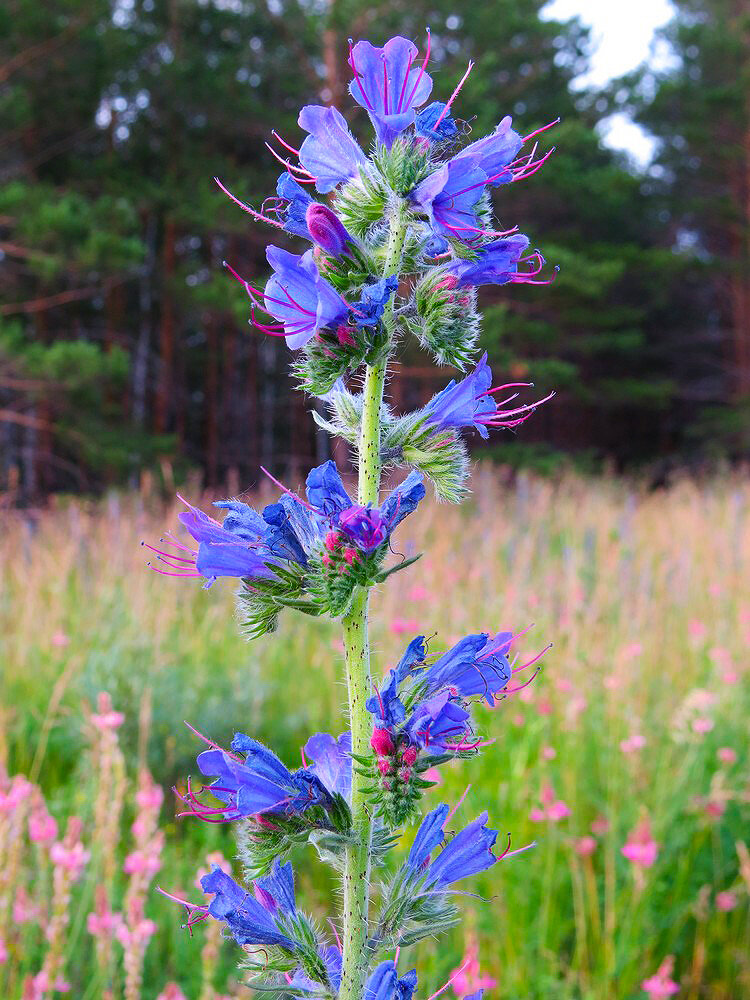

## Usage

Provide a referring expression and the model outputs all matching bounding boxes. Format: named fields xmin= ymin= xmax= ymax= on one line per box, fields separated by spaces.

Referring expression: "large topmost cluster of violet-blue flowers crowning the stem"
xmin=218 ymin=37 xmax=555 ymax=392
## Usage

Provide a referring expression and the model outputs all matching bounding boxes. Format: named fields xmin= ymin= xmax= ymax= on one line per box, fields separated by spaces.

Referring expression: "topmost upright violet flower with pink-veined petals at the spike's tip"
xmin=349 ymin=33 xmax=432 ymax=149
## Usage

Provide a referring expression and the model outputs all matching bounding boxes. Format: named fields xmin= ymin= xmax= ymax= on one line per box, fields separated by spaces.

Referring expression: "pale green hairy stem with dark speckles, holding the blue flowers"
xmin=339 ymin=204 xmax=405 ymax=1000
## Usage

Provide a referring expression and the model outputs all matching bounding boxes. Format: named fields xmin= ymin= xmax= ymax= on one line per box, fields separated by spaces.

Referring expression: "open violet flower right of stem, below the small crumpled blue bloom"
xmin=410 ymin=157 xmax=487 ymax=242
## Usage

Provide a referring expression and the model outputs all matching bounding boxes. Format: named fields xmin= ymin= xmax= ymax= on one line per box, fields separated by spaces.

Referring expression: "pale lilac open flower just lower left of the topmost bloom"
xmin=298 ymin=104 xmax=367 ymax=194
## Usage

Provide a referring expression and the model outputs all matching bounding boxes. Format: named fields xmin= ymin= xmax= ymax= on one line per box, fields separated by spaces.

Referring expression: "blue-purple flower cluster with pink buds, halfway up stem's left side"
xmin=144 ymin=461 xmax=425 ymax=635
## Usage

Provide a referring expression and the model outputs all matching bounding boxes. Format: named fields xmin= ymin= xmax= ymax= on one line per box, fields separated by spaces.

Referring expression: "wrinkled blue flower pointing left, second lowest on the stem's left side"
xmin=189 ymin=733 xmax=331 ymax=822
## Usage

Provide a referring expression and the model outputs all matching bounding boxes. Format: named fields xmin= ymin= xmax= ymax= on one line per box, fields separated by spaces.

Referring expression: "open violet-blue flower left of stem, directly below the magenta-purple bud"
xmin=260 ymin=246 xmax=348 ymax=350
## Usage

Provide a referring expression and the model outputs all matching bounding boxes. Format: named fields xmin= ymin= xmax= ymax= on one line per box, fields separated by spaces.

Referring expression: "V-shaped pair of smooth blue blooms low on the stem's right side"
xmin=405 ymin=805 xmax=498 ymax=890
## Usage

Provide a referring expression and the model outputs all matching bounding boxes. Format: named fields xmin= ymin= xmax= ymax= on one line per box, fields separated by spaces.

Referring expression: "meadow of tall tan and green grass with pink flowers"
xmin=0 ymin=466 xmax=750 ymax=1000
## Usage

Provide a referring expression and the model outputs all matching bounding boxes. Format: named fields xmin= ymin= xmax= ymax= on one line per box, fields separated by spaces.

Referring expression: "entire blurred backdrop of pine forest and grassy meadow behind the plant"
xmin=0 ymin=0 xmax=750 ymax=1000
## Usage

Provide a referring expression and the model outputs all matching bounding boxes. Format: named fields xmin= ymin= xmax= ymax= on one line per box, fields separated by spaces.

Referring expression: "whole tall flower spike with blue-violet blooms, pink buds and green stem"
xmin=156 ymin=32 xmax=552 ymax=1000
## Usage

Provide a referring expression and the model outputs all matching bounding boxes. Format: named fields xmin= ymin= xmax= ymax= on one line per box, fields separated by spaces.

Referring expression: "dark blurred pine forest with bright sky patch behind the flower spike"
xmin=0 ymin=0 xmax=750 ymax=502
